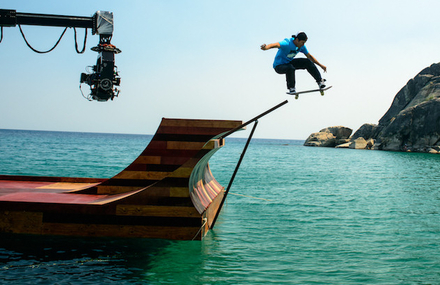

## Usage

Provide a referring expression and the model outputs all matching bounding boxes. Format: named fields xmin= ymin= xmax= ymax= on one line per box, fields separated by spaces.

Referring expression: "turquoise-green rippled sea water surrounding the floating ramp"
xmin=0 ymin=130 xmax=440 ymax=284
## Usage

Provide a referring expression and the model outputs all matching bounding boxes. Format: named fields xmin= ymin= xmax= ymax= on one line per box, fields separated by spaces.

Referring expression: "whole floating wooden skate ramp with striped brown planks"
xmin=0 ymin=118 xmax=242 ymax=240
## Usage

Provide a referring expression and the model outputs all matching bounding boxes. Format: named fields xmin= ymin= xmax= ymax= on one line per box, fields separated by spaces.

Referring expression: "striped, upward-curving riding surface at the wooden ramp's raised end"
xmin=97 ymin=118 xmax=242 ymax=194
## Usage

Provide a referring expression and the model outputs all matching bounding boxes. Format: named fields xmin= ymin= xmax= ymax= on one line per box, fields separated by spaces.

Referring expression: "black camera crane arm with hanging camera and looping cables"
xmin=0 ymin=9 xmax=121 ymax=102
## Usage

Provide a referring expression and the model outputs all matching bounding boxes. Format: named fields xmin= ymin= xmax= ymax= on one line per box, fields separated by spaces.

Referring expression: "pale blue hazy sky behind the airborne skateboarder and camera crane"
xmin=0 ymin=0 xmax=440 ymax=140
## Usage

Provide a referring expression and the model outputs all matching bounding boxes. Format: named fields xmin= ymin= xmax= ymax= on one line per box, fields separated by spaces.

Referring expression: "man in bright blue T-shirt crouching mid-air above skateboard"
xmin=261 ymin=32 xmax=327 ymax=95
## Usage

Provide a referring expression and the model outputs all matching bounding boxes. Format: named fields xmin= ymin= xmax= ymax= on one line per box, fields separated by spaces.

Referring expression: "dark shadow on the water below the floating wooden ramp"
xmin=0 ymin=234 xmax=180 ymax=284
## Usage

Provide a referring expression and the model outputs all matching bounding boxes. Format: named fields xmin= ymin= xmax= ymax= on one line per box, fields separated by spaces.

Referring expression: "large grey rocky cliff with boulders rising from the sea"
xmin=304 ymin=63 xmax=440 ymax=153
